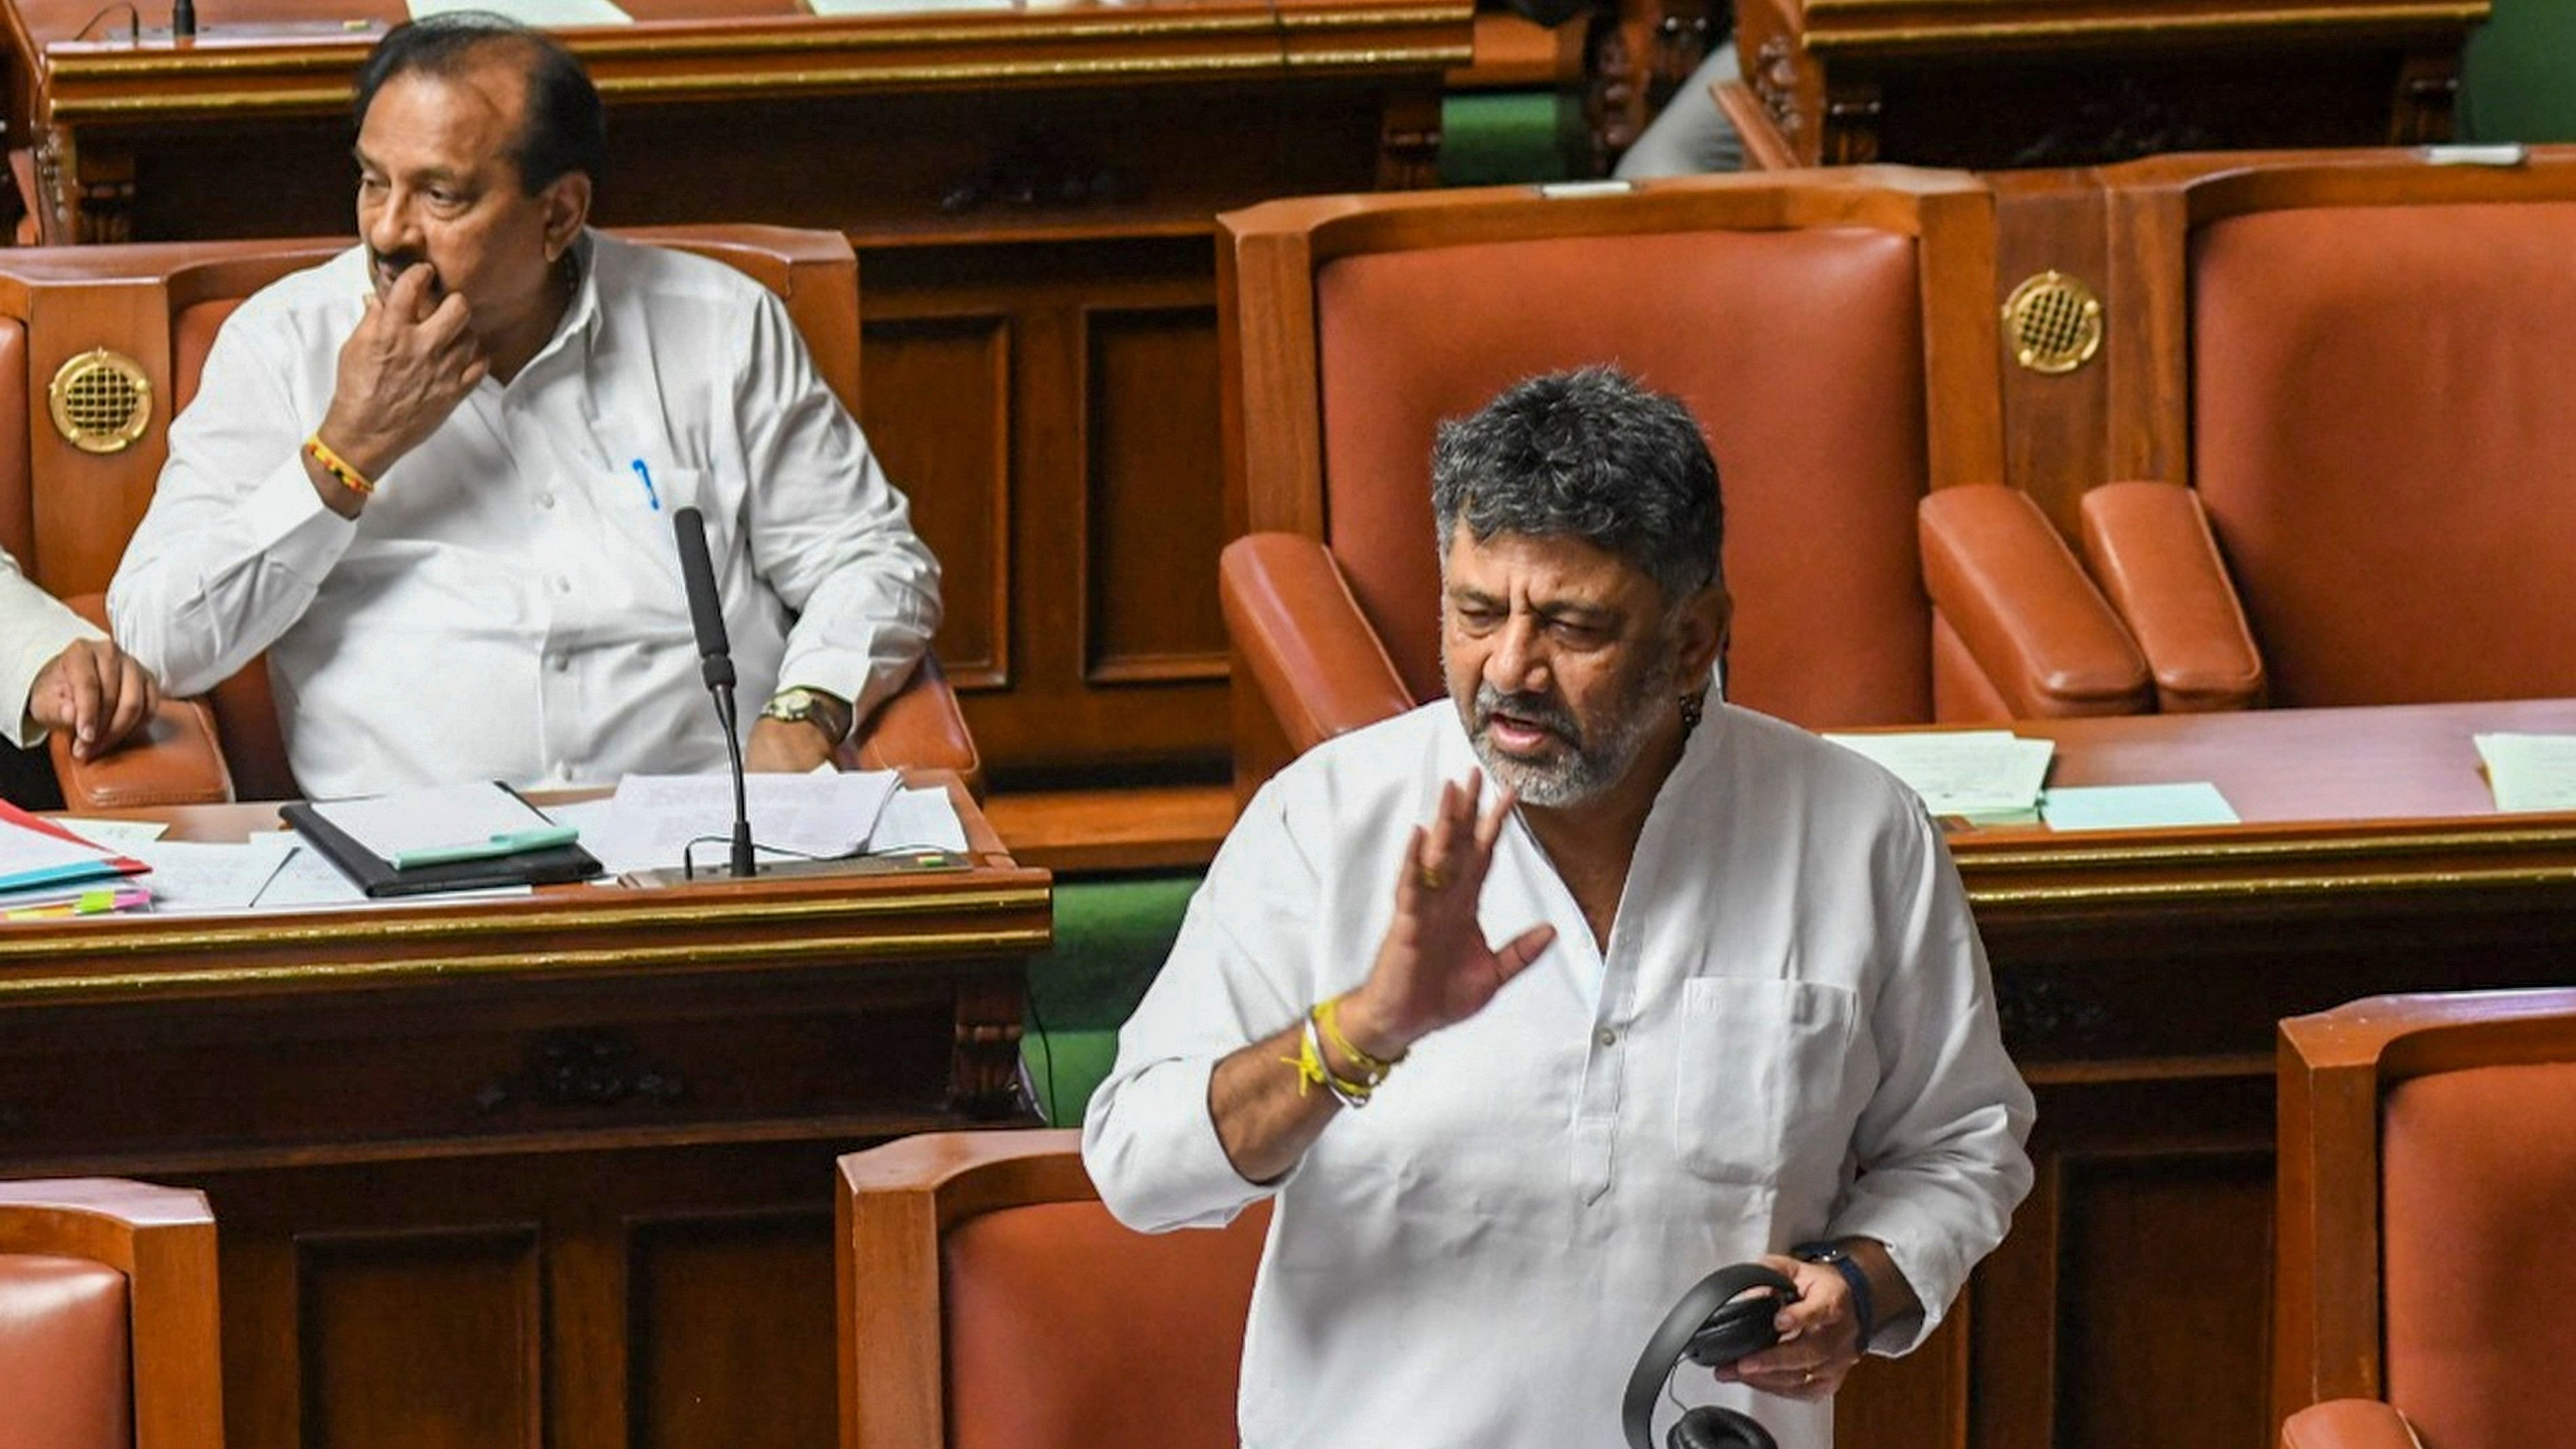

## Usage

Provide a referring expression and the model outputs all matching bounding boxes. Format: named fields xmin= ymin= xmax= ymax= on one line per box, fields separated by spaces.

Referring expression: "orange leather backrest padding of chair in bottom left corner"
xmin=0 ymin=1253 xmax=134 ymax=1449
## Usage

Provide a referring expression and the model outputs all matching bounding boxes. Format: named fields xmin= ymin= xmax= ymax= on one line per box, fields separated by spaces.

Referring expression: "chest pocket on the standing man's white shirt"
xmin=1672 ymin=976 xmax=1857 ymax=1184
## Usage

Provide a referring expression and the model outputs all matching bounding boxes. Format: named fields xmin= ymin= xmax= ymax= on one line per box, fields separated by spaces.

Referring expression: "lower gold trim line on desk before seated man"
xmin=0 ymin=927 xmax=1053 ymax=1004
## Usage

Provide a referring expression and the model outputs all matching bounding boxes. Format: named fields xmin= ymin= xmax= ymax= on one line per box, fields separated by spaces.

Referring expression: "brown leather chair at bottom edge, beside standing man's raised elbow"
xmin=840 ymin=1130 xmax=1270 ymax=1449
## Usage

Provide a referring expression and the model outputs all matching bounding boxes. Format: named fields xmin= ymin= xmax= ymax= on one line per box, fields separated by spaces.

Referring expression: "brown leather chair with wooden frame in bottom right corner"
xmin=2272 ymin=991 xmax=2576 ymax=1449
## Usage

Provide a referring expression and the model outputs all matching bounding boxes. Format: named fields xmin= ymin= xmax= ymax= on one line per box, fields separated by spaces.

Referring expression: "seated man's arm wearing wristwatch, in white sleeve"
xmin=734 ymin=293 xmax=940 ymax=769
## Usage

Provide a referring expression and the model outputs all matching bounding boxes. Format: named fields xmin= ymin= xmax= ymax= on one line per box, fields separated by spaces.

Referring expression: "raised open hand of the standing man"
xmin=1339 ymin=775 xmax=1556 ymax=1058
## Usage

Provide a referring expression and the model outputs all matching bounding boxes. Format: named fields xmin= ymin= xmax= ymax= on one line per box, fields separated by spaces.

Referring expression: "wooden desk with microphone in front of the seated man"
xmin=0 ymin=790 xmax=1051 ymax=1449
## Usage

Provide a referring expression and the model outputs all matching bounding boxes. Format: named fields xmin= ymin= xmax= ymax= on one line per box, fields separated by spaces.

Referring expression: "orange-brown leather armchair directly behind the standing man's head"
xmin=1218 ymin=167 xmax=2148 ymax=782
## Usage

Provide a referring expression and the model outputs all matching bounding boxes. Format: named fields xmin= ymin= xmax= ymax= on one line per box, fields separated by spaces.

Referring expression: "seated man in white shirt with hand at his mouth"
xmin=108 ymin=16 xmax=940 ymax=798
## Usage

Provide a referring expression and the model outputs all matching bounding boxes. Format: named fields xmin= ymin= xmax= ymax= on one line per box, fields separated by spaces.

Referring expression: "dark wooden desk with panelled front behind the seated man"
xmin=5 ymin=0 xmax=1474 ymax=782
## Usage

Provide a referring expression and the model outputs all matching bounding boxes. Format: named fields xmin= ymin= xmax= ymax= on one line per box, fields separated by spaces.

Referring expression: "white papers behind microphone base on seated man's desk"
xmin=577 ymin=769 xmax=902 ymax=873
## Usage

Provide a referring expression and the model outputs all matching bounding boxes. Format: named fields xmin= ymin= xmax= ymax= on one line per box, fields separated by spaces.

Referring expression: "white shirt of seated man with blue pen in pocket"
xmin=108 ymin=234 xmax=940 ymax=795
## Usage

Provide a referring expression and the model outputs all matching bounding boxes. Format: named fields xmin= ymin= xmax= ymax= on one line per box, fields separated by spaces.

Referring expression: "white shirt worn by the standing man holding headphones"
xmin=1082 ymin=700 xmax=2030 ymax=1449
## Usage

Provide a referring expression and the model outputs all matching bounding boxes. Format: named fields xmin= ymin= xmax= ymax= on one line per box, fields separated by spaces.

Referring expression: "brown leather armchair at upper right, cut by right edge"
xmin=2084 ymin=147 xmax=2576 ymax=710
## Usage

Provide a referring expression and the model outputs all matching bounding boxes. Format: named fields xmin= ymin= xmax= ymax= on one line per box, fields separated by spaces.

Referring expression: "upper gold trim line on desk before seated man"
xmin=0 ymin=885 xmax=1053 ymax=968
